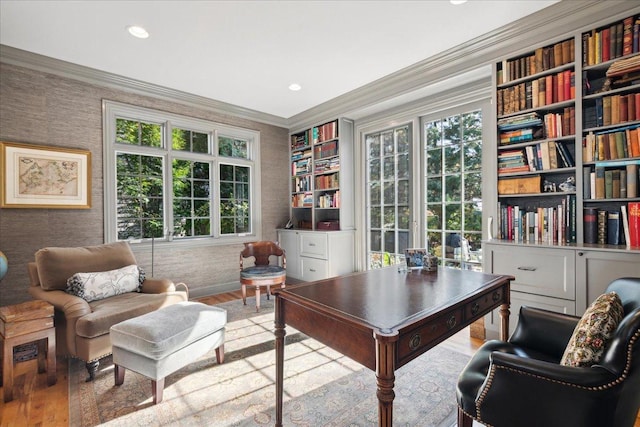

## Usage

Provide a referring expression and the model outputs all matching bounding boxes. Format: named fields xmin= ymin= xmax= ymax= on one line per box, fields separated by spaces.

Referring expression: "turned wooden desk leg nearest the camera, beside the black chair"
xmin=375 ymin=336 xmax=396 ymax=427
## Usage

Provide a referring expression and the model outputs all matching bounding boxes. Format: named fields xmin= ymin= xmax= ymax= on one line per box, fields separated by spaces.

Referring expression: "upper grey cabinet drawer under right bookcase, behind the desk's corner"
xmin=488 ymin=245 xmax=576 ymax=301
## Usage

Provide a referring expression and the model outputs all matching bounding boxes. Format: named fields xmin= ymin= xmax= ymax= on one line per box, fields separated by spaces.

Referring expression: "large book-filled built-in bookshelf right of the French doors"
xmin=492 ymin=14 xmax=640 ymax=252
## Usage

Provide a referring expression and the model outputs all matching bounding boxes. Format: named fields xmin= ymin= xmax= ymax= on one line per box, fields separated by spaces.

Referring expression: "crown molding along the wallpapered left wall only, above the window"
xmin=0 ymin=44 xmax=288 ymax=129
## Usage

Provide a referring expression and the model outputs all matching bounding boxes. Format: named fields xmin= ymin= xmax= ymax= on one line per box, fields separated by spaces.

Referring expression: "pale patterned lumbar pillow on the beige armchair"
xmin=66 ymin=265 xmax=145 ymax=302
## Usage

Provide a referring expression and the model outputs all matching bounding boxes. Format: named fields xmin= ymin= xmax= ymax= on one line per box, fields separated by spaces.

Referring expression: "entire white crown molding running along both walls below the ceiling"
xmin=0 ymin=0 xmax=640 ymax=129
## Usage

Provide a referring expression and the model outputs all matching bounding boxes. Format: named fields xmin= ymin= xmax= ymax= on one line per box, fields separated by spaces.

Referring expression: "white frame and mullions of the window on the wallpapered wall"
xmin=102 ymin=100 xmax=262 ymax=245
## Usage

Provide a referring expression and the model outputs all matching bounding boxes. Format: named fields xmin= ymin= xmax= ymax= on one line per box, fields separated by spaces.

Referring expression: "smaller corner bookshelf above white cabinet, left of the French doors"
xmin=290 ymin=119 xmax=354 ymax=230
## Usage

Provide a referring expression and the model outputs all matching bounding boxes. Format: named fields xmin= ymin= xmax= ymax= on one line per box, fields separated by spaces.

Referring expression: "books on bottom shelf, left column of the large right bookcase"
xmin=498 ymin=195 xmax=577 ymax=244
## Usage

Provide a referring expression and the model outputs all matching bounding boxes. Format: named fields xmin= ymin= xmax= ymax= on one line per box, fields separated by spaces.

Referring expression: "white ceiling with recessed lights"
xmin=0 ymin=0 xmax=558 ymax=119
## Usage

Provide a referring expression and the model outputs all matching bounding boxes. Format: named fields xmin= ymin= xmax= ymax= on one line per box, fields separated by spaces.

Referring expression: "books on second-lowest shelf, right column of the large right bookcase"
xmin=582 ymin=161 xmax=640 ymax=200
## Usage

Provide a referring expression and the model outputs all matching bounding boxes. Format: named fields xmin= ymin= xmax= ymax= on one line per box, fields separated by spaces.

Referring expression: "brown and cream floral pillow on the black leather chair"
xmin=560 ymin=292 xmax=624 ymax=367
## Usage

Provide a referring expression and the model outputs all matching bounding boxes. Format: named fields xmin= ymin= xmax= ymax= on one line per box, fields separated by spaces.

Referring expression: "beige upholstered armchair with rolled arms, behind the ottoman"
xmin=28 ymin=242 xmax=189 ymax=381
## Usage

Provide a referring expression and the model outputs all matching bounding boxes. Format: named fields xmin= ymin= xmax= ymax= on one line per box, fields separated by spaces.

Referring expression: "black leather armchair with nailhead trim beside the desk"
xmin=456 ymin=278 xmax=640 ymax=427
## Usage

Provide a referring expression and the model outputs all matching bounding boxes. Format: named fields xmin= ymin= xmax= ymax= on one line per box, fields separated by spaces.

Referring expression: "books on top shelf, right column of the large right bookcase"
xmin=582 ymin=16 xmax=640 ymax=66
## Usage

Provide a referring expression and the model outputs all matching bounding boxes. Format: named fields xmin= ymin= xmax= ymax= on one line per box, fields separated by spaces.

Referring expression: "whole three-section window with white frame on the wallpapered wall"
xmin=104 ymin=102 xmax=260 ymax=243
